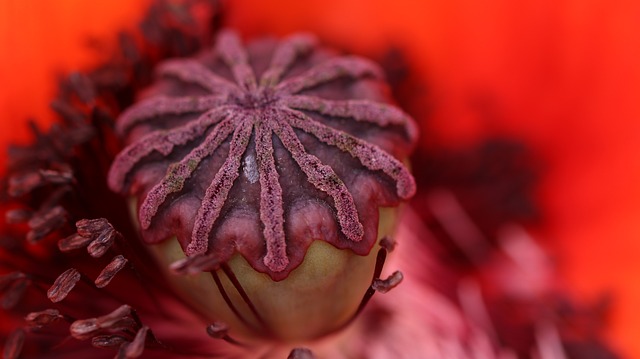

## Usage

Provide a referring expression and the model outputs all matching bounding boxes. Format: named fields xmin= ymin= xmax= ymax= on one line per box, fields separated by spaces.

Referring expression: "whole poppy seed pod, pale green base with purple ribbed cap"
xmin=108 ymin=30 xmax=417 ymax=341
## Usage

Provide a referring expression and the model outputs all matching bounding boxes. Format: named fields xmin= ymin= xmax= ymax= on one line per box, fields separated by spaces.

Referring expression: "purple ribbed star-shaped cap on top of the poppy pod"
xmin=108 ymin=30 xmax=417 ymax=280
